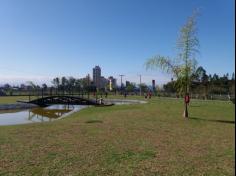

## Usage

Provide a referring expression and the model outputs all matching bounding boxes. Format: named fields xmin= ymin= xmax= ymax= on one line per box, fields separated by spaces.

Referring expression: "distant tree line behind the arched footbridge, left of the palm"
xmin=0 ymin=75 xmax=149 ymax=95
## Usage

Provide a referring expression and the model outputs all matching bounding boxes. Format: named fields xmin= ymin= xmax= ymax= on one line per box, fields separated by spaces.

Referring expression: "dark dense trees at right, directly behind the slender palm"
xmin=163 ymin=66 xmax=235 ymax=99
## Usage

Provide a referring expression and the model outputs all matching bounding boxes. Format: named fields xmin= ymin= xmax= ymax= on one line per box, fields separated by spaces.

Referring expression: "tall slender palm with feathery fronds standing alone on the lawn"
xmin=145 ymin=12 xmax=199 ymax=117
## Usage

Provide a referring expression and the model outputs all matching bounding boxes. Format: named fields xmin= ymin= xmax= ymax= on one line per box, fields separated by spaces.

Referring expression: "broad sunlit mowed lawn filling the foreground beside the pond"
xmin=0 ymin=97 xmax=235 ymax=176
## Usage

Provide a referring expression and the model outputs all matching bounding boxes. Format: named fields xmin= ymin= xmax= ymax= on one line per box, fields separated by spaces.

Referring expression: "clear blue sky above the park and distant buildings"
xmin=0 ymin=0 xmax=235 ymax=84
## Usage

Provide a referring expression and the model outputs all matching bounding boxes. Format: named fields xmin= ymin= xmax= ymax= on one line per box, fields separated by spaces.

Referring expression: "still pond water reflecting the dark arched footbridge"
xmin=0 ymin=105 xmax=87 ymax=126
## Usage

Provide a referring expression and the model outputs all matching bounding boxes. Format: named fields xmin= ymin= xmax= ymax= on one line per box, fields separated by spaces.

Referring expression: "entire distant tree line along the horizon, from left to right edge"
xmin=0 ymin=70 xmax=235 ymax=99
